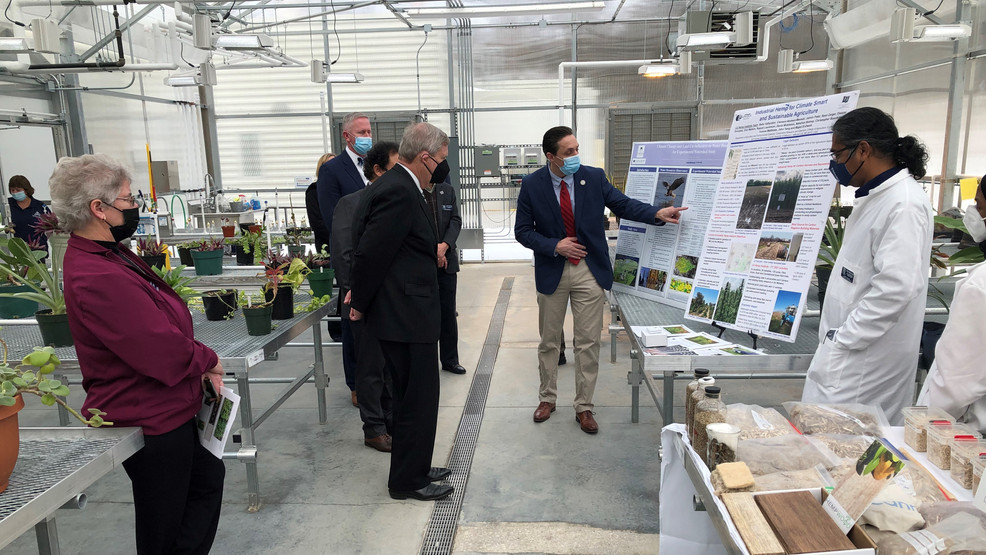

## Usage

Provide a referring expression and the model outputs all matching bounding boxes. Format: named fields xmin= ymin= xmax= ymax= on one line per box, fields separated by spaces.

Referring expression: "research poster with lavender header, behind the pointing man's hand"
xmin=613 ymin=141 xmax=727 ymax=309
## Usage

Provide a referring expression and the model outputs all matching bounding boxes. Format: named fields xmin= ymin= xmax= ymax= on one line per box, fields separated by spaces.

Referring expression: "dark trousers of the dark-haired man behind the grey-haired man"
xmin=347 ymin=318 xmax=393 ymax=439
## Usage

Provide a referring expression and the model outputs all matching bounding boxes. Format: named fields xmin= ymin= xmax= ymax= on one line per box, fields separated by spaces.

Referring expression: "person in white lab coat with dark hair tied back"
xmin=801 ymin=108 xmax=934 ymax=425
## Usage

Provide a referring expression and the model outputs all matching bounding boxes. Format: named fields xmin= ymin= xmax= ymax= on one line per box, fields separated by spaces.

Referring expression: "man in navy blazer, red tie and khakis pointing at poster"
xmin=514 ymin=126 xmax=687 ymax=434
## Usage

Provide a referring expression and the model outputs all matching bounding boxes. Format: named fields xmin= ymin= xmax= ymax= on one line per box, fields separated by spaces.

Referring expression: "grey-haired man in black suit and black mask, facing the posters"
xmin=349 ymin=122 xmax=452 ymax=501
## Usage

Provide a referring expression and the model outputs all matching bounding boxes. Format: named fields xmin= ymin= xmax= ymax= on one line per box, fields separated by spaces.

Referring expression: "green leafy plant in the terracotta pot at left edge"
xmin=0 ymin=339 xmax=113 ymax=428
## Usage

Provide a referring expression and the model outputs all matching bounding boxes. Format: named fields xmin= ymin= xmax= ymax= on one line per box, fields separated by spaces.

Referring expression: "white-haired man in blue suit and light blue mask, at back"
xmin=316 ymin=112 xmax=373 ymax=407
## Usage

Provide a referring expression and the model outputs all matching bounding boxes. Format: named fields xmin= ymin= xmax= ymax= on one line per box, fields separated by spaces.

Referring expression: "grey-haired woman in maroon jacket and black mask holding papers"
xmin=49 ymin=155 xmax=226 ymax=555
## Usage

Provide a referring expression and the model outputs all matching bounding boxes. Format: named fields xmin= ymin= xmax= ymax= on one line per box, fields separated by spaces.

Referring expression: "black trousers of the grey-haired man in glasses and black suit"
xmin=380 ymin=340 xmax=439 ymax=491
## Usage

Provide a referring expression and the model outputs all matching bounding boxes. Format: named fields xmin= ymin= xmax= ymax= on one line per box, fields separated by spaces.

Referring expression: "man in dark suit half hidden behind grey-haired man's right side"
xmin=425 ymin=180 xmax=466 ymax=374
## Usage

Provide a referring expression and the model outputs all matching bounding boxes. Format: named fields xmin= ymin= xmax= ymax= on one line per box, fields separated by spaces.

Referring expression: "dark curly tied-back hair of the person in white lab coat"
xmin=832 ymin=108 xmax=928 ymax=179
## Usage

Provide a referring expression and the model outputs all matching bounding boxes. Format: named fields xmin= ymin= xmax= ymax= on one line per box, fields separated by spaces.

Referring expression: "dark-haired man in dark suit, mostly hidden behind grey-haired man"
xmin=331 ymin=141 xmax=399 ymax=453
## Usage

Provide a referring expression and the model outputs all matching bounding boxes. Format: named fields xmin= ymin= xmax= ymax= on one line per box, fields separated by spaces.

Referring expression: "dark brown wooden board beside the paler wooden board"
xmin=754 ymin=491 xmax=856 ymax=553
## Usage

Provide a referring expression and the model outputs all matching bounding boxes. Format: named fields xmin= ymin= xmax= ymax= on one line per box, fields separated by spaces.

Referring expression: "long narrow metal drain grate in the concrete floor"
xmin=421 ymin=277 xmax=514 ymax=555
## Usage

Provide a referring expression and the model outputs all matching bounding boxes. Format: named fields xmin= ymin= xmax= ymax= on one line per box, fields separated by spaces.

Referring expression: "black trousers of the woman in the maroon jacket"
xmin=123 ymin=420 xmax=226 ymax=555
